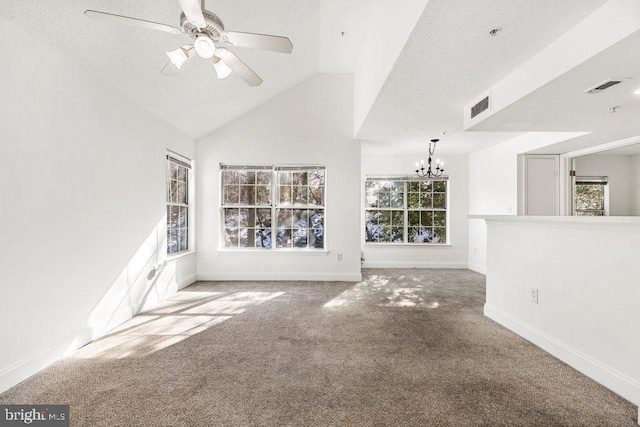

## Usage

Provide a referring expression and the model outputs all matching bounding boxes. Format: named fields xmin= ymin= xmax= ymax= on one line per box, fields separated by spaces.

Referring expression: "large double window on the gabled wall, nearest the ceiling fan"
xmin=221 ymin=165 xmax=325 ymax=249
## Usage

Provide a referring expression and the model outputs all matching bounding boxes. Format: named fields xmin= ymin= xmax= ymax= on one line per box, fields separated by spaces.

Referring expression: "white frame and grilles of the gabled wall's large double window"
xmin=219 ymin=163 xmax=327 ymax=253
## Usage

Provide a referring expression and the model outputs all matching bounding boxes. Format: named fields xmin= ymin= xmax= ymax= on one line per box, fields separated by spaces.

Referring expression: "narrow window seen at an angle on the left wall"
xmin=167 ymin=154 xmax=191 ymax=254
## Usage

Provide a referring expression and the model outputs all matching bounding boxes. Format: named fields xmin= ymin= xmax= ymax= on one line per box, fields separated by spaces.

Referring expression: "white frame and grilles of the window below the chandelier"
xmin=362 ymin=175 xmax=451 ymax=247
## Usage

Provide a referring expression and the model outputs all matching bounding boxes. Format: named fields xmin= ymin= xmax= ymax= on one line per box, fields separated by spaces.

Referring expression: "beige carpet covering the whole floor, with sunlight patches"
xmin=0 ymin=269 xmax=637 ymax=427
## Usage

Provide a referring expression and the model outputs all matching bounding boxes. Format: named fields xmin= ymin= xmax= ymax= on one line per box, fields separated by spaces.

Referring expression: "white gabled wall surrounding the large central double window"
xmin=197 ymin=74 xmax=361 ymax=281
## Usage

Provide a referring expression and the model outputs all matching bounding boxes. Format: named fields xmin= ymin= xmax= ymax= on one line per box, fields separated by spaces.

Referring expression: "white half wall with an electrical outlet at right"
xmin=485 ymin=216 xmax=640 ymax=405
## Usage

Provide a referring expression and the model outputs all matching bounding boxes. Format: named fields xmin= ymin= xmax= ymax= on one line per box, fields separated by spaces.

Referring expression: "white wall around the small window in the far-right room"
xmin=575 ymin=154 xmax=640 ymax=216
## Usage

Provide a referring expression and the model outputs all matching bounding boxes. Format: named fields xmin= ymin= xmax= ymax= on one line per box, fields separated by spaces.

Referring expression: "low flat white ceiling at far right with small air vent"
xmin=477 ymin=31 xmax=640 ymax=154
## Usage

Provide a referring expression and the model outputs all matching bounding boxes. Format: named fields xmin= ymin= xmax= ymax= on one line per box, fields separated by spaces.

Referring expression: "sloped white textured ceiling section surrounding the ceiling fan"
xmin=0 ymin=0 xmax=320 ymax=139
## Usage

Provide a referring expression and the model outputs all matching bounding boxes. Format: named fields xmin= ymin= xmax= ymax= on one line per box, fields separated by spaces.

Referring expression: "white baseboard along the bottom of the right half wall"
xmin=484 ymin=304 xmax=640 ymax=405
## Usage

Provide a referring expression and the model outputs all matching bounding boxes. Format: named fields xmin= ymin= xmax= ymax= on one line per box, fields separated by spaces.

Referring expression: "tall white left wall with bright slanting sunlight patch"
xmin=0 ymin=18 xmax=195 ymax=392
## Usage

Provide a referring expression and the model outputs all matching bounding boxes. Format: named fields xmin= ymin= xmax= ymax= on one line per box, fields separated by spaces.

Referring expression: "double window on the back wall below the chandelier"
xmin=365 ymin=178 xmax=448 ymax=244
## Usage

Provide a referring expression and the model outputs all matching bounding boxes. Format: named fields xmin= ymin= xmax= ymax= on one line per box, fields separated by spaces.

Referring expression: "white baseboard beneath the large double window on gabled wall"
xmin=198 ymin=272 xmax=362 ymax=282
